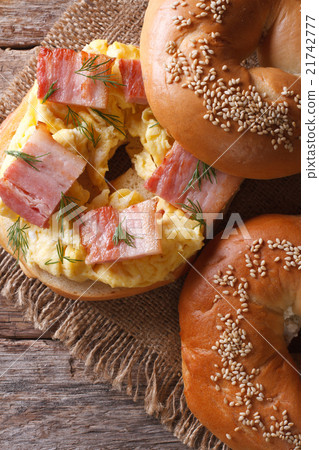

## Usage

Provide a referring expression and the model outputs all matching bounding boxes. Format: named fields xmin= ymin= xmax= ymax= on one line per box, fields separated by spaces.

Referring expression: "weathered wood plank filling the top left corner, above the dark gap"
xmin=0 ymin=0 xmax=72 ymax=48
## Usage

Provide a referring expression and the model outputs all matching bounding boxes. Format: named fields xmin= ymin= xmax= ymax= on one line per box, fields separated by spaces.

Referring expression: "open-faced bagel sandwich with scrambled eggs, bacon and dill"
xmin=0 ymin=40 xmax=242 ymax=300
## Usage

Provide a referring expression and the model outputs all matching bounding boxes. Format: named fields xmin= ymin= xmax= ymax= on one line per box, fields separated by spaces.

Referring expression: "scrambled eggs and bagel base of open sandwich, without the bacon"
xmin=0 ymin=40 xmax=210 ymax=300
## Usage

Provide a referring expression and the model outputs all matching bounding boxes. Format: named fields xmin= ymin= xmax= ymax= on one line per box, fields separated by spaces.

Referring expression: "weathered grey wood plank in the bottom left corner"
xmin=0 ymin=339 xmax=186 ymax=450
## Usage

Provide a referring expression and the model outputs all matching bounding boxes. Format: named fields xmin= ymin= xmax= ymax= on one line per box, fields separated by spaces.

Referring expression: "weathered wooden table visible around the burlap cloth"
xmin=0 ymin=0 xmax=186 ymax=450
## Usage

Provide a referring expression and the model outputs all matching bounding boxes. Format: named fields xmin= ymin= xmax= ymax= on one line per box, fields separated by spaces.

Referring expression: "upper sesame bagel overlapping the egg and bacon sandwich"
xmin=141 ymin=0 xmax=301 ymax=179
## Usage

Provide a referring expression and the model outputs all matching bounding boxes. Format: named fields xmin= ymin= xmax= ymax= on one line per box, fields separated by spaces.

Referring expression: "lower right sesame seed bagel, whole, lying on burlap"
xmin=179 ymin=215 xmax=301 ymax=450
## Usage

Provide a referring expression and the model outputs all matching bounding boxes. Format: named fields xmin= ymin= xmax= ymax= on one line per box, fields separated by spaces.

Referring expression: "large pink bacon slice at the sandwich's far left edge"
xmin=0 ymin=124 xmax=86 ymax=228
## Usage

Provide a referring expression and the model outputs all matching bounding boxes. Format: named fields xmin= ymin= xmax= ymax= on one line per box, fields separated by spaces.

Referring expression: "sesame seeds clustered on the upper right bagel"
xmin=166 ymin=0 xmax=300 ymax=152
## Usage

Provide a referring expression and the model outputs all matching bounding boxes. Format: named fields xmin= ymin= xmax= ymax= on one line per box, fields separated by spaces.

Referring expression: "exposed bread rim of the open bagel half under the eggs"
xmin=0 ymin=94 xmax=187 ymax=300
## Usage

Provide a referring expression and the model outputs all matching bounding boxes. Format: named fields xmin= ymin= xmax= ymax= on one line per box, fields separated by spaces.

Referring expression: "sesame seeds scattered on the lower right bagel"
xmin=205 ymin=238 xmax=301 ymax=449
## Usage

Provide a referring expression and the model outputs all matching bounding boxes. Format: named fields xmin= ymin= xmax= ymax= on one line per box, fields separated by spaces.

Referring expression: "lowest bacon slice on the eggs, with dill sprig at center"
xmin=80 ymin=199 xmax=162 ymax=264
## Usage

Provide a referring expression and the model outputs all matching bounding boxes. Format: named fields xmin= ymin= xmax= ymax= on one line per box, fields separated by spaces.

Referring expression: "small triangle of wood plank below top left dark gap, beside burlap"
xmin=0 ymin=48 xmax=35 ymax=95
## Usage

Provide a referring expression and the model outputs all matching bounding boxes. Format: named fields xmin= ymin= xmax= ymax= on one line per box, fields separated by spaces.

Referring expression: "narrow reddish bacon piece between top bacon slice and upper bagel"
xmin=119 ymin=59 xmax=147 ymax=105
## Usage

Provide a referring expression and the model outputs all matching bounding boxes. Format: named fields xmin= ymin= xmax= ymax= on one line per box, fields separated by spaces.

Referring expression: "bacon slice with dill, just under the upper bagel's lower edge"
xmin=144 ymin=142 xmax=243 ymax=213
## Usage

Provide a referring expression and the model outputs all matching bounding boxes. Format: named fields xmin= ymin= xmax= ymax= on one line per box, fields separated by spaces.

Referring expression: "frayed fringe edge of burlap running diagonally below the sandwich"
xmin=0 ymin=249 xmax=228 ymax=450
